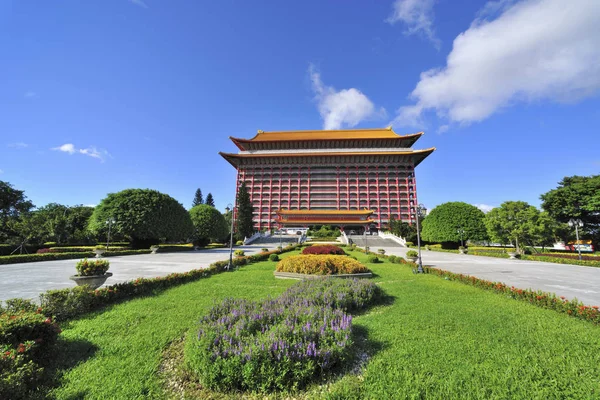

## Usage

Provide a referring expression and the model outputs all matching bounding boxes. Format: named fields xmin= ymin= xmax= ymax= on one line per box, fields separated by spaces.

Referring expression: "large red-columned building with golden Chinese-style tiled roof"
xmin=219 ymin=127 xmax=435 ymax=232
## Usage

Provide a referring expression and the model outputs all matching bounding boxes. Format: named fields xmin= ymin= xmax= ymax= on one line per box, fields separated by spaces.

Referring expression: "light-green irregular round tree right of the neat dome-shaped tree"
xmin=485 ymin=201 xmax=547 ymax=251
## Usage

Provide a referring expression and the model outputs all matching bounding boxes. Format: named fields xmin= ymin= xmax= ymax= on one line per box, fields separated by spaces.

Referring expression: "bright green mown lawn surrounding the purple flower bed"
xmin=45 ymin=252 xmax=600 ymax=399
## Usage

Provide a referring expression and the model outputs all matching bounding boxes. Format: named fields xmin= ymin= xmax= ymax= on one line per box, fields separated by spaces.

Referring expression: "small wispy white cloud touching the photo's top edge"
xmin=385 ymin=0 xmax=441 ymax=50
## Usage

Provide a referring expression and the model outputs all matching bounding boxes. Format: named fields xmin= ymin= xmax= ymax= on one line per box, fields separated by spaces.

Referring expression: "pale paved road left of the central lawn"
xmin=0 ymin=244 xmax=276 ymax=301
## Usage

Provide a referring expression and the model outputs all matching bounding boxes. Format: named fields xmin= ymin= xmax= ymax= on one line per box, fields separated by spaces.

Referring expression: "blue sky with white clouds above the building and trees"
xmin=0 ymin=0 xmax=600 ymax=214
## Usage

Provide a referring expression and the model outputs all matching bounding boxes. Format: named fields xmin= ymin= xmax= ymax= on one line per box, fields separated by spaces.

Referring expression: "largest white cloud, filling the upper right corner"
xmin=394 ymin=0 xmax=600 ymax=125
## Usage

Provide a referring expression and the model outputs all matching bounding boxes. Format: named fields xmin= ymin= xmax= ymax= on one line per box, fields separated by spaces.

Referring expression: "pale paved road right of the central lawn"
xmin=385 ymin=247 xmax=600 ymax=305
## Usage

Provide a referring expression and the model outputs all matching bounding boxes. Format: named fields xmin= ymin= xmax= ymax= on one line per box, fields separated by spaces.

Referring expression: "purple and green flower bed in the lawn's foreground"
xmin=185 ymin=279 xmax=380 ymax=392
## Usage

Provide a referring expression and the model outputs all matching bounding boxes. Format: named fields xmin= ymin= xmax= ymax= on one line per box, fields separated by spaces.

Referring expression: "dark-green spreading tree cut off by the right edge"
xmin=540 ymin=175 xmax=600 ymax=244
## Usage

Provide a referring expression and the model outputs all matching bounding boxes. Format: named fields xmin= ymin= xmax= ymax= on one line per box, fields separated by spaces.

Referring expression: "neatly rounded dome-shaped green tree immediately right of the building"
xmin=421 ymin=201 xmax=487 ymax=247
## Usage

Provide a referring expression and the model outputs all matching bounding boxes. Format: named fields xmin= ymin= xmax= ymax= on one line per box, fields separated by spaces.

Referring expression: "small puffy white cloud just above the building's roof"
xmin=308 ymin=64 xmax=386 ymax=129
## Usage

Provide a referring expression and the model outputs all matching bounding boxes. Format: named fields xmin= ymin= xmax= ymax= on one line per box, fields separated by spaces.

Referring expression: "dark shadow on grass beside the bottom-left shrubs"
xmin=32 ymin=338 xmax=98 ymax=400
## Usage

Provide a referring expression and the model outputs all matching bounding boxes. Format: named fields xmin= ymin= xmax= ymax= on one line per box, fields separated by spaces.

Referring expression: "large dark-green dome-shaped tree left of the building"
xmin=88 ymin=189 xmax=194 ymax=248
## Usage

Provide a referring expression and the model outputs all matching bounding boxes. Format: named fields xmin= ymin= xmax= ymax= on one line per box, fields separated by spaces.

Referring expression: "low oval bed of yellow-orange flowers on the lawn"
xmin=276 ymin=255 xmax=369 ymax=275
